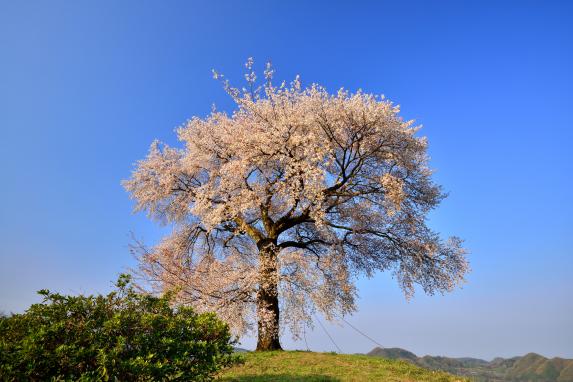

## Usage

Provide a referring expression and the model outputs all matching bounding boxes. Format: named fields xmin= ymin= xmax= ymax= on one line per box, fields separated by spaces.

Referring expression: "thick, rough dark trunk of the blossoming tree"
xmin=257 ymin=243 xmax=282 ymax=351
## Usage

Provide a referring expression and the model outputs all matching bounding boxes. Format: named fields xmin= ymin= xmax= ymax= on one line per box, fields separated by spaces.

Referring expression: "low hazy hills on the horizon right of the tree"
xmin=367 ymin=347 xmax=573 ymax=382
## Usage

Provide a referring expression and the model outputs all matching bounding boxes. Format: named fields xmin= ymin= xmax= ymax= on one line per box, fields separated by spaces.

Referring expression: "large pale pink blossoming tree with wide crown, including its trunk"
xmin=124 ymin=59 xmax=468 ymax=350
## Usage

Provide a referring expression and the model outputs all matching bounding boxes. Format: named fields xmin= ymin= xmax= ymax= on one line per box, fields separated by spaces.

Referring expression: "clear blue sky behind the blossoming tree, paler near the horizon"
xmin=0 ymin=0 xmax=573 ymax=358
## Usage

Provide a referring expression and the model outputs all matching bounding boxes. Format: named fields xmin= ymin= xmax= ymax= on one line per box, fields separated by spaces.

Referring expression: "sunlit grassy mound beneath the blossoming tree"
xmin=219 ymin=351 xmax=469 ymax=382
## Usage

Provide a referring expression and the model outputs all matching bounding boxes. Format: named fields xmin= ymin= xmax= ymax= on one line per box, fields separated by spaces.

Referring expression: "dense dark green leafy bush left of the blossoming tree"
xmin=0 ymin=275 xmax=235 ymax=381
